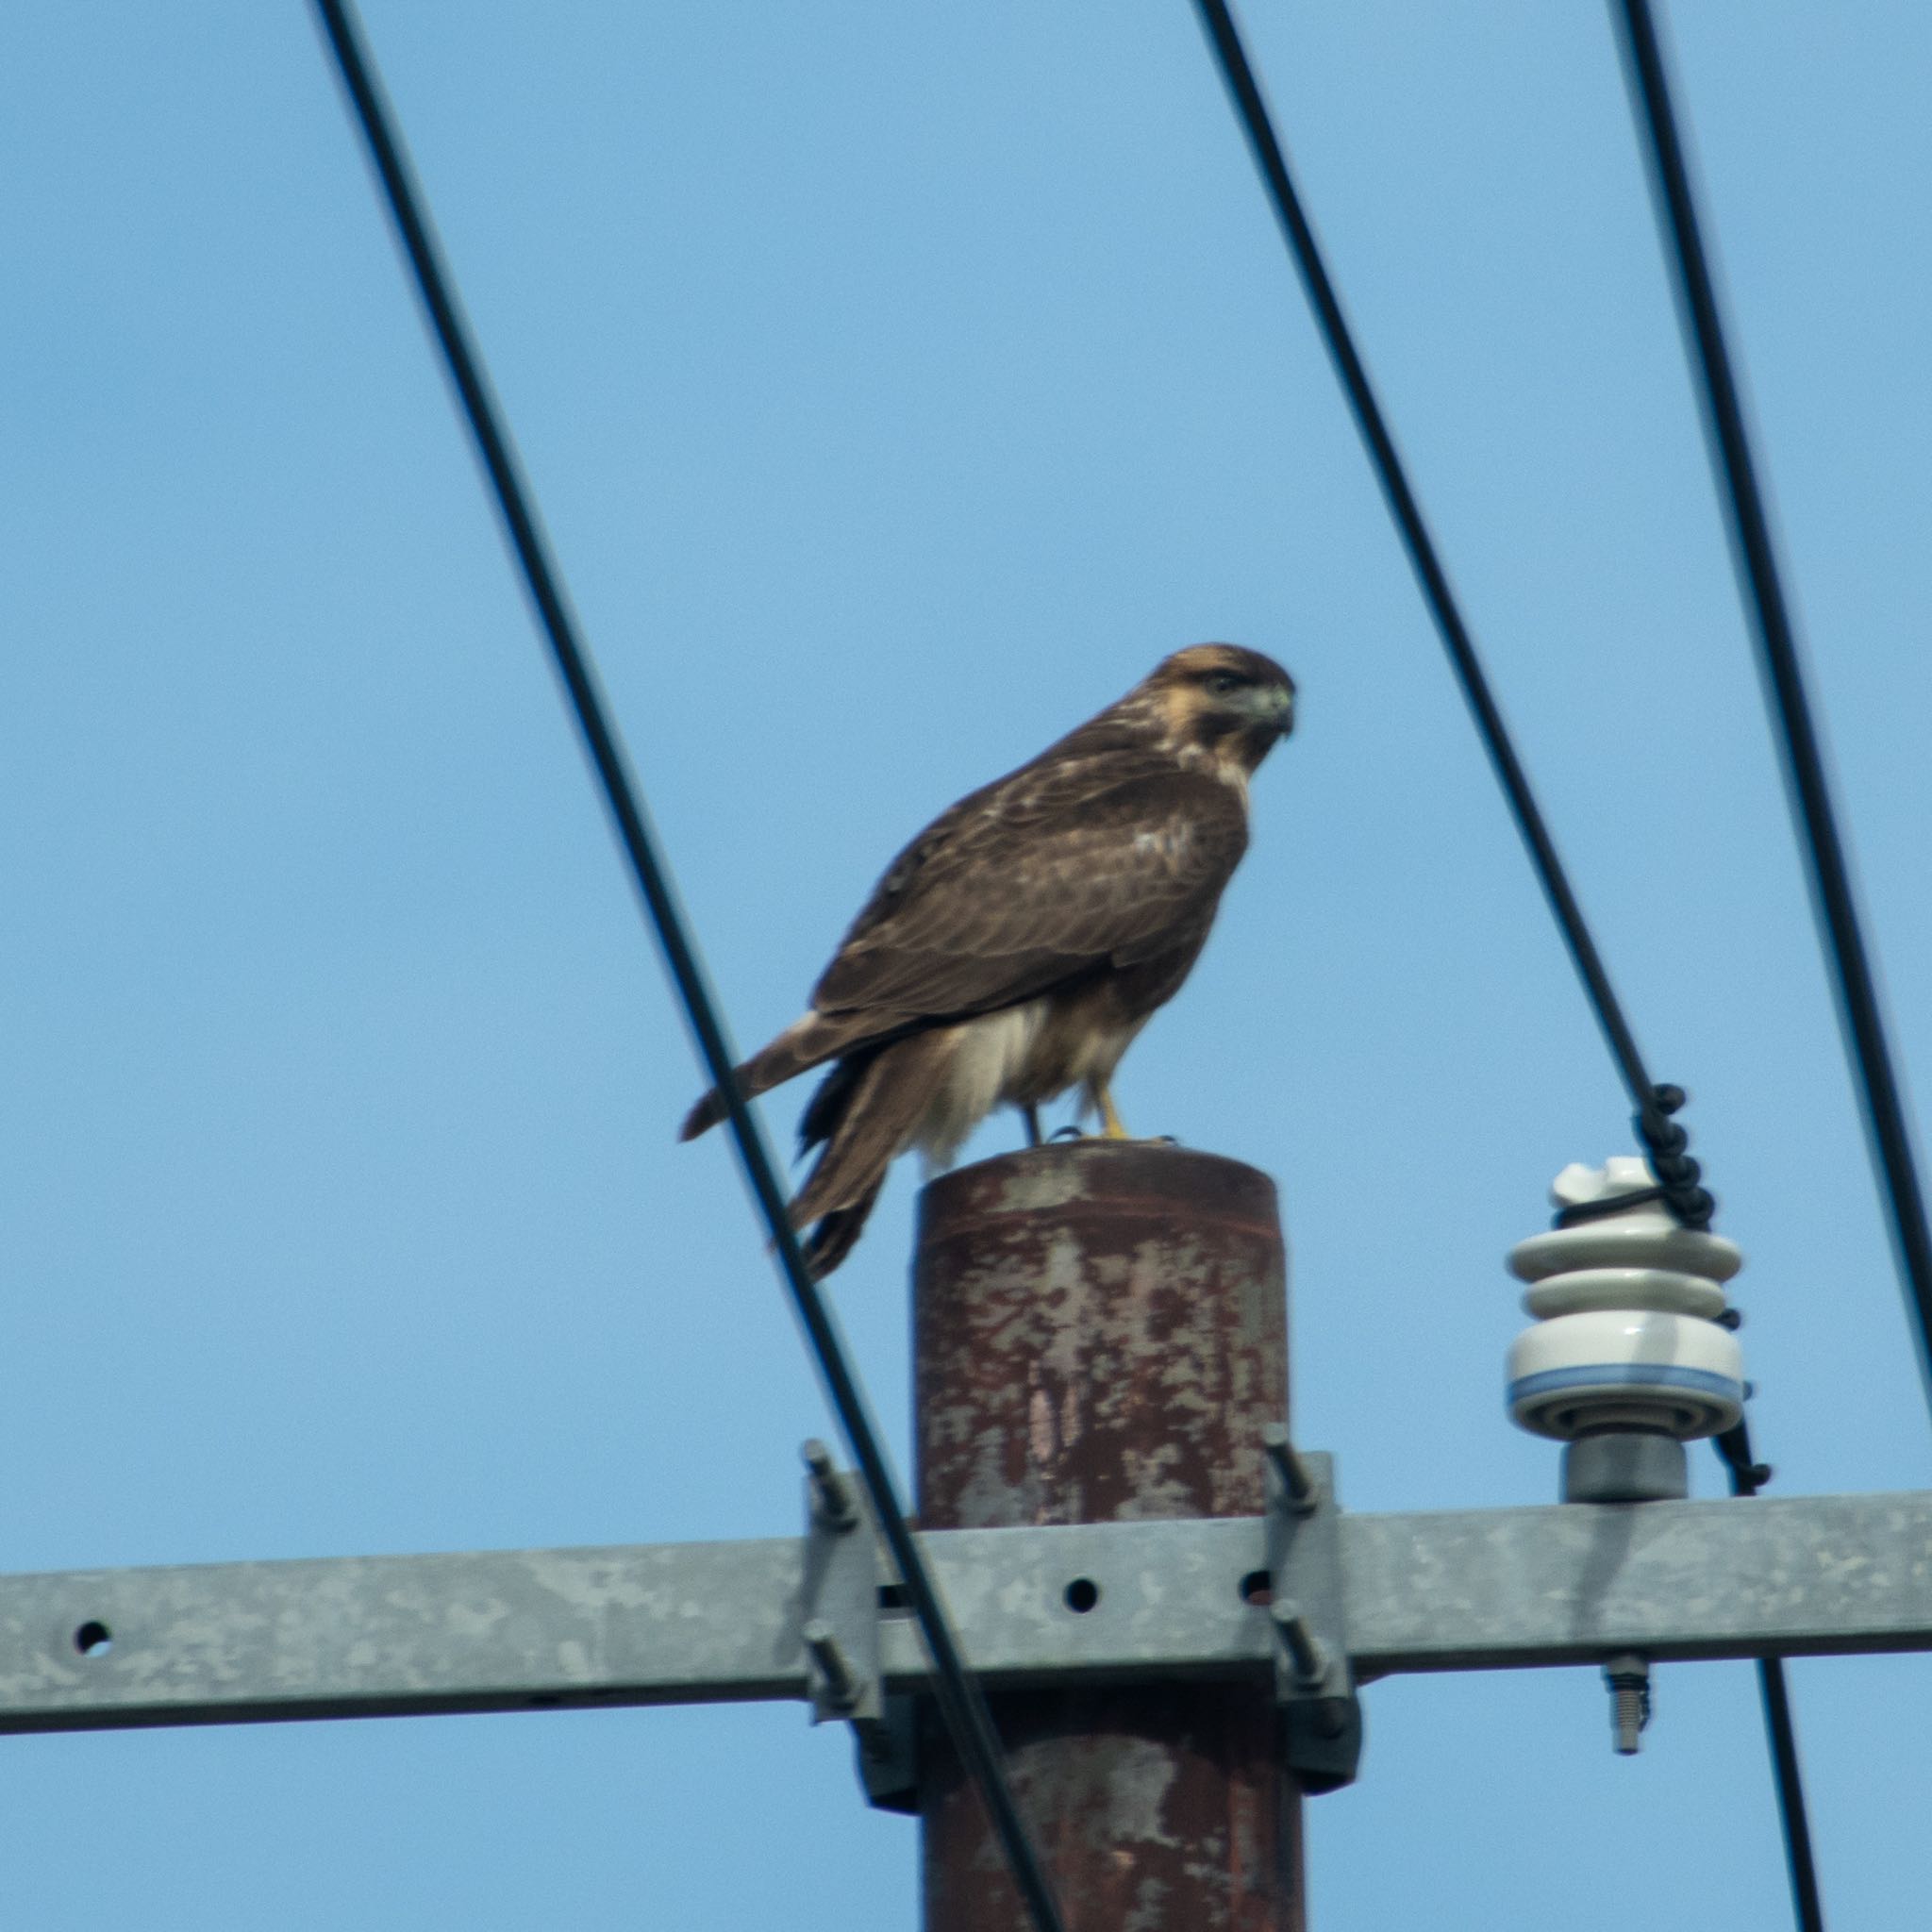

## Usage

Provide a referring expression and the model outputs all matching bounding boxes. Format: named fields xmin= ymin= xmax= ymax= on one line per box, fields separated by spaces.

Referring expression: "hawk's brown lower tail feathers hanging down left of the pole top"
xmin=792 ymin=1028 xmax=958 ymax=1275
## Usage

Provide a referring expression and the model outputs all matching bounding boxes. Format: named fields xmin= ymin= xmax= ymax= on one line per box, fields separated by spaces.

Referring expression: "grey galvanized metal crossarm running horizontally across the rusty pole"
xmin=0 ymin=1491 xmax=1932 ymax=1731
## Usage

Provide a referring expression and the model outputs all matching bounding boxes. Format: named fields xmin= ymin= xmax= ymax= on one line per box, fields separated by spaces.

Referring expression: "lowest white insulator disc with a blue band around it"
xmin=1508 ymin=1307 xmax=1744 ymax=1441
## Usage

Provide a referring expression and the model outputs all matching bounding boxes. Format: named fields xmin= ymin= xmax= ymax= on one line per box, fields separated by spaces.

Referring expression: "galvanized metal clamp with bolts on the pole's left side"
xmin=796 ymin=1438 xmax=920 ymax=1810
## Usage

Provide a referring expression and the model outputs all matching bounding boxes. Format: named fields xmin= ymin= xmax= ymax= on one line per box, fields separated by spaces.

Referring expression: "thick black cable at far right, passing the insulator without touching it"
xmin=1611 ymin=0 xmax=1932 ymax=1422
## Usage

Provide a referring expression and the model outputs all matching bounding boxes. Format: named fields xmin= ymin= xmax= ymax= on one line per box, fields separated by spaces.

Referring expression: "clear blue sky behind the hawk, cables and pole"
xmin=0 ymin=0 xmax=1932 ymax=1932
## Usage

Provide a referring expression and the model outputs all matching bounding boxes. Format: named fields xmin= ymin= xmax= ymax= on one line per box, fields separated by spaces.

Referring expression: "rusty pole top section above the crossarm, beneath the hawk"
xmin=914 ymin=1140 xmax=1287 ymax=1528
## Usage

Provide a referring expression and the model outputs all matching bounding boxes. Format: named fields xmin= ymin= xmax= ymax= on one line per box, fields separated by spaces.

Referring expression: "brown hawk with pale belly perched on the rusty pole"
xmin=682 ymin=643 xmax=1294 ymax=1275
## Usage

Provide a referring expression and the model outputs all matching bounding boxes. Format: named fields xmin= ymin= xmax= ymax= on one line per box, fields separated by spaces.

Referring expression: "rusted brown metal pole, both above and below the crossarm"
xmin=914 ymin=1140 xmax=1302 ymax=1932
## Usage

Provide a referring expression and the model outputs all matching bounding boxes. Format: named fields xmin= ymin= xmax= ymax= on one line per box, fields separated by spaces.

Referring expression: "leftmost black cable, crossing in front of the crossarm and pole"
xmin=315 ymin=0 xmax=1062 ymax=1932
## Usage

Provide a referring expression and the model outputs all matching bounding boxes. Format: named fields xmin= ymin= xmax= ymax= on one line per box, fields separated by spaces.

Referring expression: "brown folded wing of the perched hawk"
xmin=811 ymin=756 xmax=1248 ymax=1018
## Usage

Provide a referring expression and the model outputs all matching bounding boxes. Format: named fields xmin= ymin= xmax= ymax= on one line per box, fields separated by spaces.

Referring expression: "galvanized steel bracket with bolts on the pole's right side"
xmin=1263 ymin=1424 xmax=1362 ymax=1793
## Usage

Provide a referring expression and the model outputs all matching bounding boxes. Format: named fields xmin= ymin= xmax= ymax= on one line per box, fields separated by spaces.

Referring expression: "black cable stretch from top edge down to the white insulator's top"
xmin=1196 ymin=0 xmax=1716 ymax=1226
